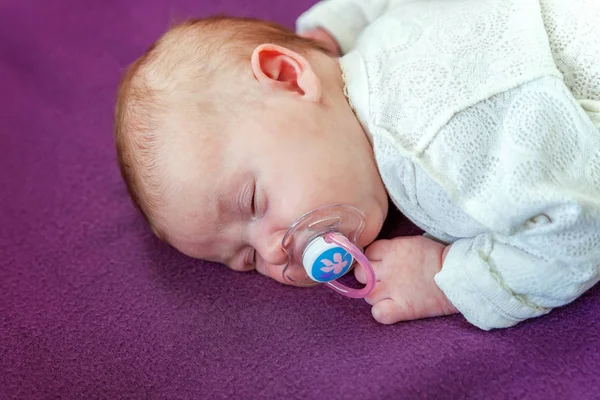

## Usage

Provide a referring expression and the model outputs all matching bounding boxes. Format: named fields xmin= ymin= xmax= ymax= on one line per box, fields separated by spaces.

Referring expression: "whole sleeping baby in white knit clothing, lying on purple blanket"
xmin=115 ymin=0 xmax=600 ymax=330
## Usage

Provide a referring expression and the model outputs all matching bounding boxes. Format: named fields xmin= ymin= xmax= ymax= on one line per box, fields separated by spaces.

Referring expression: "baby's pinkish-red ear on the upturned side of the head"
xmin=252 ymin=44 xmax=321 ymax=102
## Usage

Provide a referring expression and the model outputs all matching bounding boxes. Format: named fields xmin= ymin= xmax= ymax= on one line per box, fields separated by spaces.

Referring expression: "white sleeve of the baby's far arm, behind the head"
xmin=296 ymin=0 xmax=388 ymax=54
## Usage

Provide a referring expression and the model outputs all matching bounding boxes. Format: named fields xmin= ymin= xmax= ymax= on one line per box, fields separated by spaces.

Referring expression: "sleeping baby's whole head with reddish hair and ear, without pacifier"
xmin=115 ymin=17 xmax=388 ymax=281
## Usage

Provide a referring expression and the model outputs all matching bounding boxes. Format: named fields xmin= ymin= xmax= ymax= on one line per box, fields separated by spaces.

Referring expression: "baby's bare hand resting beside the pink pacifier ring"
xmin=354 ymin=236 xmax=458 ymax=324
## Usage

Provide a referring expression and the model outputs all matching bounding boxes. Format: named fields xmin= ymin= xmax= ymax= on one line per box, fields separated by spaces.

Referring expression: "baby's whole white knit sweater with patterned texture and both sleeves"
xmin=298 ymin=0 xmax=600 ymax=330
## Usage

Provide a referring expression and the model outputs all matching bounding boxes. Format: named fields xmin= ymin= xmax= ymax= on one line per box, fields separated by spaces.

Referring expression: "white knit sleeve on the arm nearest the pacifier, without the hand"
xmin=433 ymin=79 xmax=600 ymax=330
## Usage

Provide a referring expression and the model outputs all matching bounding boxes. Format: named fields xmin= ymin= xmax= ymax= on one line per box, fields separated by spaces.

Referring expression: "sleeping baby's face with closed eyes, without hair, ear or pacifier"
xmin=160 ymin=45 xmax=388 ymax=282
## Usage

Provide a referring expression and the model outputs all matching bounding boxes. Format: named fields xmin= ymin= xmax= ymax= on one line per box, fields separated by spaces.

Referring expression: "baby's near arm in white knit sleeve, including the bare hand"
xmin=356 ymin=78 xmax=600 ymax=330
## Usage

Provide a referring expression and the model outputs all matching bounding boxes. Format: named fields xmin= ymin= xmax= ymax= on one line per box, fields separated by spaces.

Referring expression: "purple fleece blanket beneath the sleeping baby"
xmin=0 ymin=0 xmax=600 ymax=400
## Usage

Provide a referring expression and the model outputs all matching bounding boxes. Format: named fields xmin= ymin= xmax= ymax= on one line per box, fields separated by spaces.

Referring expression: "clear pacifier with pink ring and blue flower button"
xmin=281 ymin=204 xmax=375 ymax=298
